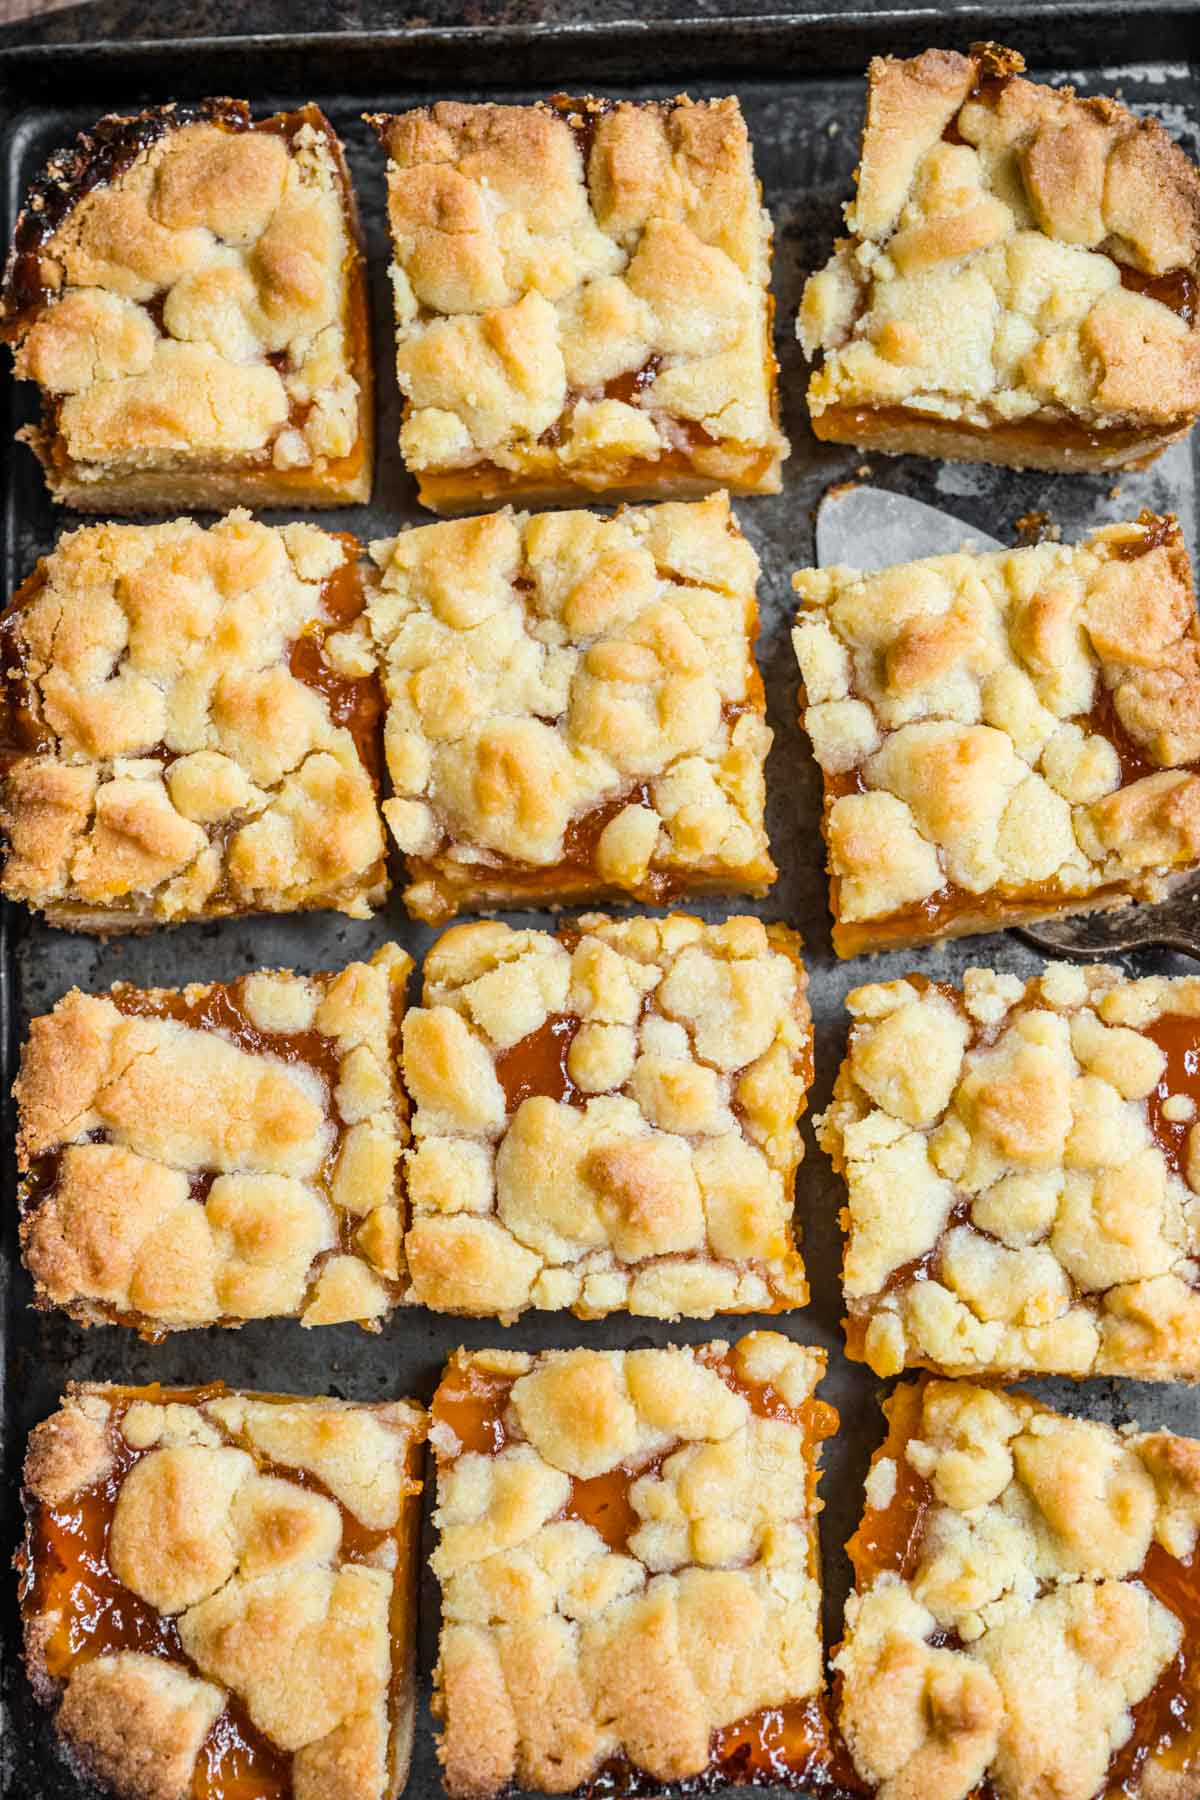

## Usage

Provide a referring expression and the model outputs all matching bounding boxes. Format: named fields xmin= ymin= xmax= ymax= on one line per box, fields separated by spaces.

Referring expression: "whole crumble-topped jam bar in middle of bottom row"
xmin=430 ymin=1332 xmax=837 ymax=1800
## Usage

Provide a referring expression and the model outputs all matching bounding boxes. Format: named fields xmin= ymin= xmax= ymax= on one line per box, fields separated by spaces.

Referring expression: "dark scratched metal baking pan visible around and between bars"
xmin=0 ymin=14 xmax=1200 ymax=1800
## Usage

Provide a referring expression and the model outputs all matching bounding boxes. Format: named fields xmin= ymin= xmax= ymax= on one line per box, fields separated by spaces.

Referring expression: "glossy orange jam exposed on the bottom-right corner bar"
xmin=835 ymin=1377 xmax=1200 ymax=1800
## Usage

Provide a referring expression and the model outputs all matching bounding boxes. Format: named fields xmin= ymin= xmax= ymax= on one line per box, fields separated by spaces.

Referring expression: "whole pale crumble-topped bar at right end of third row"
xmin=817 ymin=963 xmax=1200 ymax=1381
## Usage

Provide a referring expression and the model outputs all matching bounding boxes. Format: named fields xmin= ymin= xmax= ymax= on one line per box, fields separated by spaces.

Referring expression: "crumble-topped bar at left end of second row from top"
xmin=0 ymin=513 xmax=387 ymax=932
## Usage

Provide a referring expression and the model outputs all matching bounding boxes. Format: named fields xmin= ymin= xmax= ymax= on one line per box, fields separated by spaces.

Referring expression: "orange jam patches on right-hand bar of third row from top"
xmin=844 ymin=976 xmax=1200 ymax=1363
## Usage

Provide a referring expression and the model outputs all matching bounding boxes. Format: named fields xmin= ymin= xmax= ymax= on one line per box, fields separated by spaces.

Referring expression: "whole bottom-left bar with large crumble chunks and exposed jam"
xmin=16 ymin=1381 xmax=426 ymax=1800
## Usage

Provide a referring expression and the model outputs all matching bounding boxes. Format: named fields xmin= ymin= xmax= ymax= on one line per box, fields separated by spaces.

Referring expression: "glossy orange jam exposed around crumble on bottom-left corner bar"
xmin=16 ymin=1382 xmax=417 ymax=1800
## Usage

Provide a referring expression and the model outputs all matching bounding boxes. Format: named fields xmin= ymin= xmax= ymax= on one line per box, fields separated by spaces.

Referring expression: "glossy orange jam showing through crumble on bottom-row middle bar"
xmin=432 ymin=1346 xmax=837 ymax=1800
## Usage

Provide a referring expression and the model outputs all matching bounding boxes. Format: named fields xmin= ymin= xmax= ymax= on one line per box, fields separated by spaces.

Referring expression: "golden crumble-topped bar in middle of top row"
xmin=372 ymin=95 xmax=788 ymax=513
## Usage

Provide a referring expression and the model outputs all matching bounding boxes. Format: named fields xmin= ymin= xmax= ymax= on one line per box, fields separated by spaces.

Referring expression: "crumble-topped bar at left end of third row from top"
xmin=14 ymin=943 xmax=412 ymax=1337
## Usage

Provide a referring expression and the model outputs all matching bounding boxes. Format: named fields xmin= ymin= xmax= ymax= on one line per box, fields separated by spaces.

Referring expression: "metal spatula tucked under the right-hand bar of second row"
xmin=817 ymin=484 xmax=1200 ymax=958
